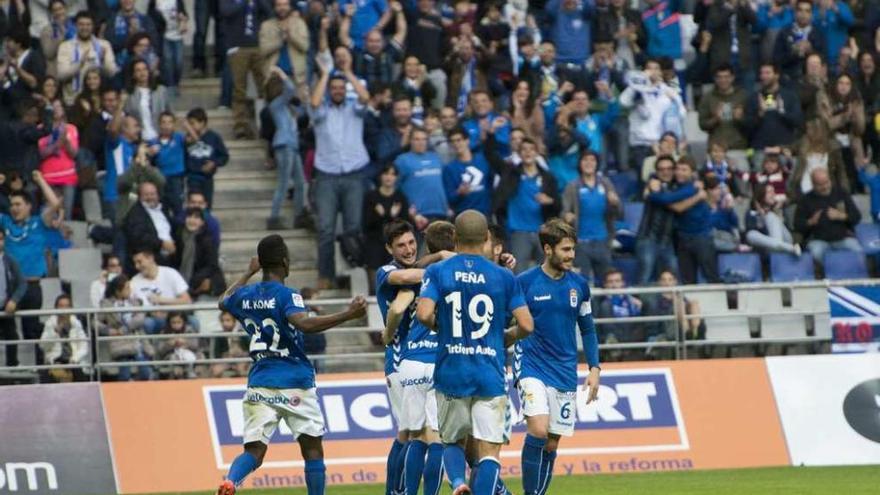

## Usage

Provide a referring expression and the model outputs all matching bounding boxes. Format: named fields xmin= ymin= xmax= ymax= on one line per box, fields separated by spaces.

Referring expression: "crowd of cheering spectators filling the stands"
xmin=0 ymin=0 xmax=880 ymax=379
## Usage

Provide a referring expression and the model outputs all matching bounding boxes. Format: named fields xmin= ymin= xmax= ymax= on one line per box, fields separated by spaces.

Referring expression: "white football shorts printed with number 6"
xmin=517 ymin=378 xmax=577 ymax=437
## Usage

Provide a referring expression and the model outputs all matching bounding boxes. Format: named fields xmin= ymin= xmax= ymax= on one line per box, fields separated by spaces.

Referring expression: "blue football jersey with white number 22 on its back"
xmin=223 ymin=282 xmax=315 ymax=389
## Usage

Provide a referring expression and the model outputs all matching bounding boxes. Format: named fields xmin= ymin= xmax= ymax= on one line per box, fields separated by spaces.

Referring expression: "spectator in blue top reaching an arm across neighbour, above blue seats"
xmin=648 ymin=159 xmax=719 ymax=284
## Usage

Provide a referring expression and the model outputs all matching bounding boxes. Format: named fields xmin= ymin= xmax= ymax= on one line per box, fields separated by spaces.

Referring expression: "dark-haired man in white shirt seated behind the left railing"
xmin=131 ymin=249 xmax=192 ymax=334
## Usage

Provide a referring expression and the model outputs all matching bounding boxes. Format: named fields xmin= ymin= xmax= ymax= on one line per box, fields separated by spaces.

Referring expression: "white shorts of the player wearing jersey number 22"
xmin=242 ymin=388 xmax=324 ymax=445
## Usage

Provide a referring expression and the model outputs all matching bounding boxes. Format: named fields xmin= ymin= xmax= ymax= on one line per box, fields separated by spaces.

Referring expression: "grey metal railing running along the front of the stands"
xmin=0 ymin=279 xmax=880 ymax=380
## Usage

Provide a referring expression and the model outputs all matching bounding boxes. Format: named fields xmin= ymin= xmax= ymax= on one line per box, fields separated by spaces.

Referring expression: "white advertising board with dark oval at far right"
xmin=766 ymin=354 xmax=880 ymax=466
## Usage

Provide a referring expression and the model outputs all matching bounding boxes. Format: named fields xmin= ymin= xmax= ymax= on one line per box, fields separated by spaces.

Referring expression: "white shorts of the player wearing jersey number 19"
xmin=437 ymin=391 xmax=510 ymax=443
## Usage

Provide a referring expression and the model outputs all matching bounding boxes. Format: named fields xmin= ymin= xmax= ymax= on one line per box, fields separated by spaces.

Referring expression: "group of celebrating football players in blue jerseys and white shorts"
xmin=218 ymin=210 xmax=600 ymax=495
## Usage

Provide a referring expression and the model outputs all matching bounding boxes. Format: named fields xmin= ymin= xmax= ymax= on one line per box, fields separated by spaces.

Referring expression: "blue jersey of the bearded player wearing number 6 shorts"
xmin=513 ymin=266 xmax=592 ymax=392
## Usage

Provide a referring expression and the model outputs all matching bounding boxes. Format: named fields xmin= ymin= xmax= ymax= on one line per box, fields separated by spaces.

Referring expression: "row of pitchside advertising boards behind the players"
xmin=0 ymin=354 xmax=880 ymax=493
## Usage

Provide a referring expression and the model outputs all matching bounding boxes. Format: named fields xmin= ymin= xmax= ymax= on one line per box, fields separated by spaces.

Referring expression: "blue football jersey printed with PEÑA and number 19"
xmin=421 ymin=254 xmax=525 ymax=397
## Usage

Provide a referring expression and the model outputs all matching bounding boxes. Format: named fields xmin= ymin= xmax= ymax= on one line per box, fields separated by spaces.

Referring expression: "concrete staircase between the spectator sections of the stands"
xmin=175 ymin=78 xmax=382 ymax=372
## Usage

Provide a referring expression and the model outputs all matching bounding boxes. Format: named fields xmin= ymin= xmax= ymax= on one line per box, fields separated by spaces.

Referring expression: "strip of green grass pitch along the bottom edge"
xmin=138 ymin=466 xmax=880 ymax=495
